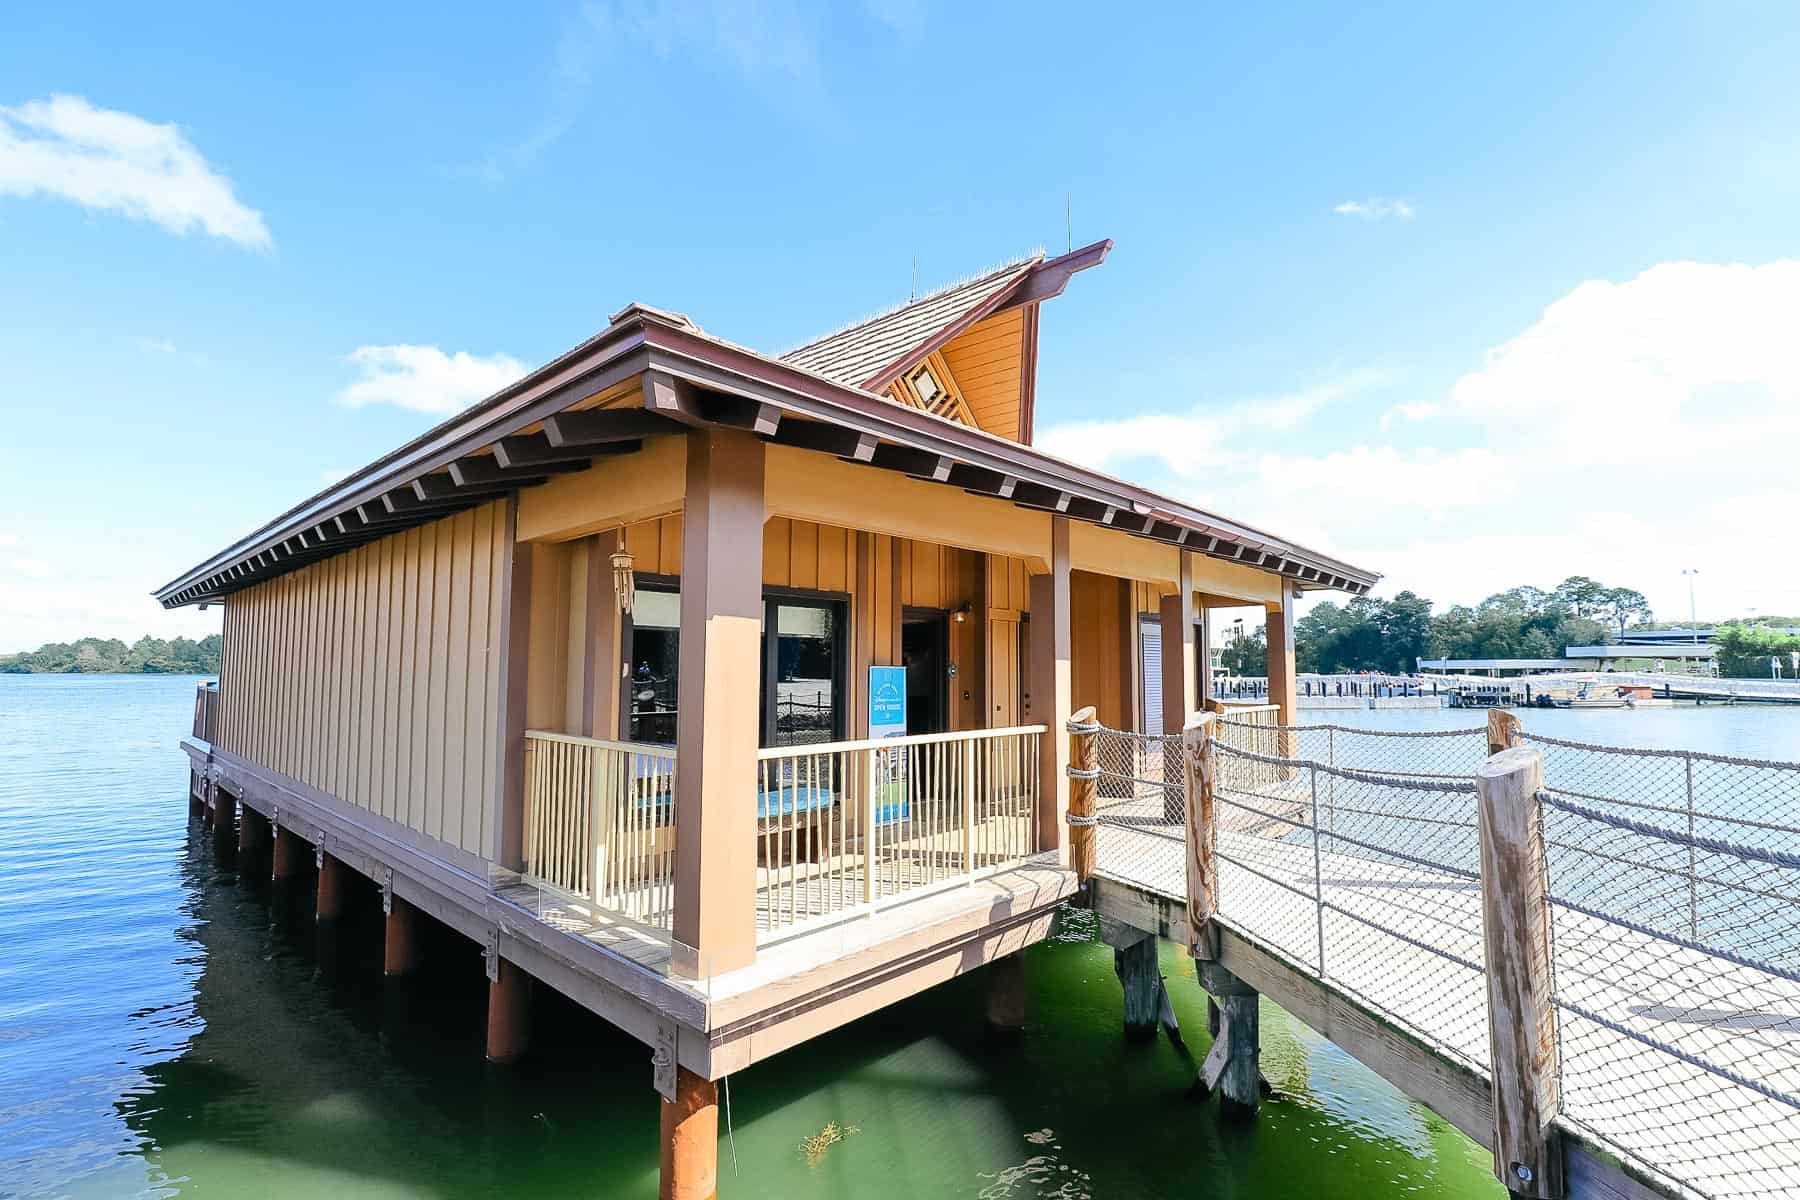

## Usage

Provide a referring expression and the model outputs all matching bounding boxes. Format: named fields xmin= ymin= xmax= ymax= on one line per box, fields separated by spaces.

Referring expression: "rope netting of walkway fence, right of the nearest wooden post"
xmin=1523 ymin=734 xmax=1800 ymax=1196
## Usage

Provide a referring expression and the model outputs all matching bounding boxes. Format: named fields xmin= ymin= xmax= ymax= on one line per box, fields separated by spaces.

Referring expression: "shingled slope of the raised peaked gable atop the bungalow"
xmin=781 ymin=250 xmax=1044 ymax=389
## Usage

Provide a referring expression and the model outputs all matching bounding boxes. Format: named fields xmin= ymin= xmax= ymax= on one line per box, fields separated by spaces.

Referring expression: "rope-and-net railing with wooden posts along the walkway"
xmin=1096 ymin=716 xmax=1800 ymax=1196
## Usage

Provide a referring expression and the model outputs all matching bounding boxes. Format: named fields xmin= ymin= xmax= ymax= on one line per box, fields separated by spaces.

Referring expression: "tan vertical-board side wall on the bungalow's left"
xmin=220 ymin=502 xmax=509 ymax=858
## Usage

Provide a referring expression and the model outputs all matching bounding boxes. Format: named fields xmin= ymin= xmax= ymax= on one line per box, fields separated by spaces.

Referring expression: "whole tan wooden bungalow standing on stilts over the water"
xmin=157 ymin=241 xmax=1377 ymax=1196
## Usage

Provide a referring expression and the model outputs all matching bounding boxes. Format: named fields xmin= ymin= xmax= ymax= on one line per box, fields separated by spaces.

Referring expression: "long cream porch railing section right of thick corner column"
xmin=756 ymin=725 xmax=1044 ymax=941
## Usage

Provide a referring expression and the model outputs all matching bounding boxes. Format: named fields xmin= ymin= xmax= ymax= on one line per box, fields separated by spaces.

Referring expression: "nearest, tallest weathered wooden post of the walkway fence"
xmin=1474 ymin=744 xmax=1562 ymax=1200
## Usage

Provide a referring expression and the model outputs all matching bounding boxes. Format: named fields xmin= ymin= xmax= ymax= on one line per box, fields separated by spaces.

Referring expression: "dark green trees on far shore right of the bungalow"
xmin=1281 ymin=576 xmax=1656 ymax=675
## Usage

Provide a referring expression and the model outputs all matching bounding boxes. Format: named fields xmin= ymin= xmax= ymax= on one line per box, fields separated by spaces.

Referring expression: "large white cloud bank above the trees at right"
xmin=1048 ymin=261 xmax=1800 ymax=619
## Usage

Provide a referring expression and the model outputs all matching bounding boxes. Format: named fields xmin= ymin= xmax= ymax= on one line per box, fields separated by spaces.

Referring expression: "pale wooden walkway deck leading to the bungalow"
xmin=1096 ymin=784 xmax=1800 ymax=1198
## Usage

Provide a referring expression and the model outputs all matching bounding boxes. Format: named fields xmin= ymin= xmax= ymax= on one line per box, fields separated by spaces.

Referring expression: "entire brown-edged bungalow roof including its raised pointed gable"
xmin=155 ymin=241 xmax=1381 ymax=608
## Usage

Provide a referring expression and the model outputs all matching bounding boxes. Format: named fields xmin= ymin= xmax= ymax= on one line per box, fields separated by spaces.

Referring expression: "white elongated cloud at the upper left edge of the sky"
xmin=0 ymin=95 xmax=272 ymax=248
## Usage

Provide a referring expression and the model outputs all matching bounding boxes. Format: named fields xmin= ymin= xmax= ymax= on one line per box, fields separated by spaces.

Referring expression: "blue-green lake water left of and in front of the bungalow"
xmin=0 ymin=676 xmax=1503 ymax=1200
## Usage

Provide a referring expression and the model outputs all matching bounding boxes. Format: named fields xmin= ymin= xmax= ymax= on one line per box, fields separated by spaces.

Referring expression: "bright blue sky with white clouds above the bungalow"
xmin=0 ymin=0 xmax=1800 ymax=651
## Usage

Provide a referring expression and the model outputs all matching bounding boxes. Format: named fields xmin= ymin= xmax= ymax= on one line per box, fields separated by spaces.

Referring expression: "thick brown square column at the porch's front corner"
xmin=673 ymin=428 xmax=763 ymax=977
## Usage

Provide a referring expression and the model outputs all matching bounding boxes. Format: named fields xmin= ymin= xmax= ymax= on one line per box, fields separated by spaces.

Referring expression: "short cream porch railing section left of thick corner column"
xmin=526 ymin=730 xmax=675 ymax=930
